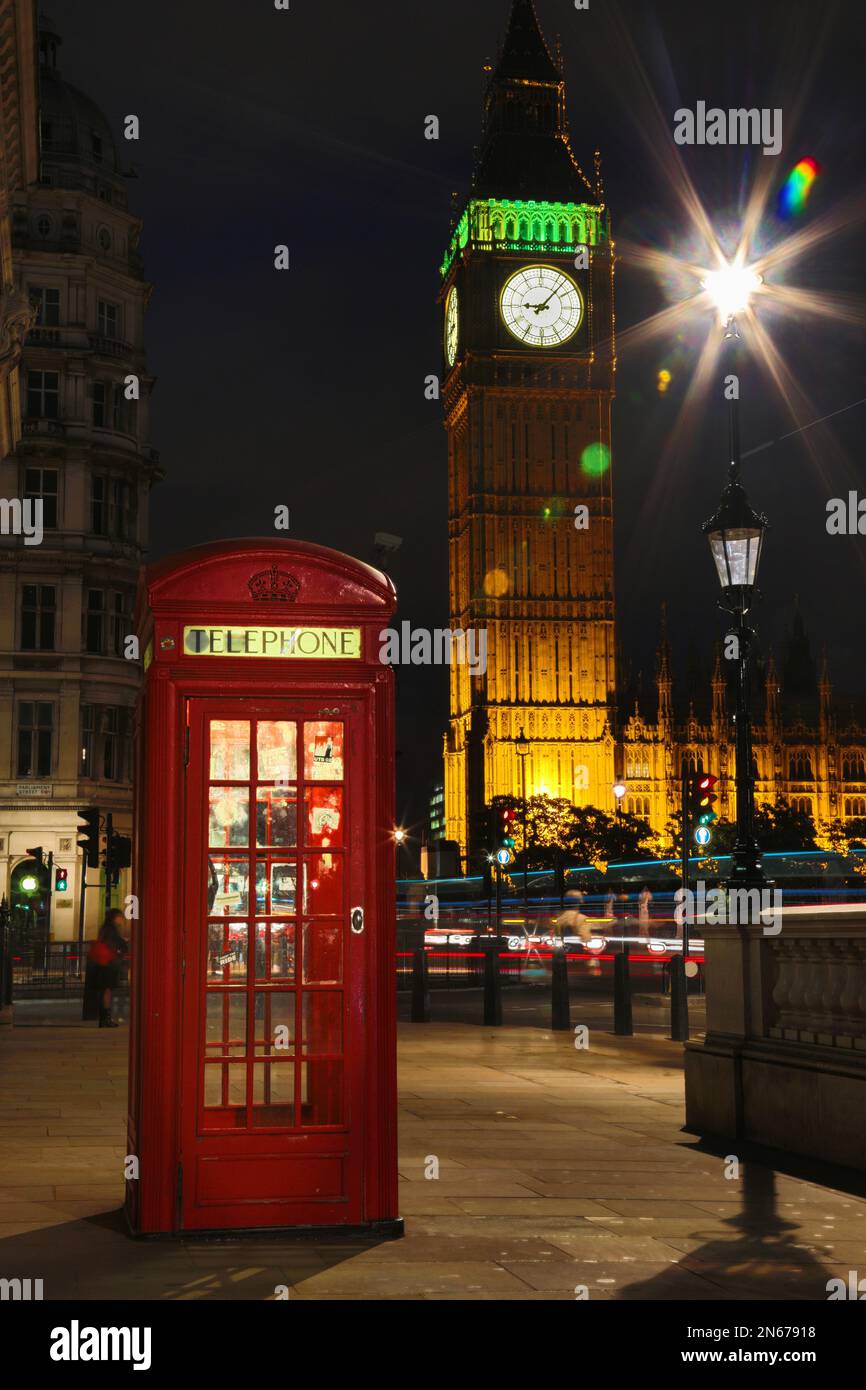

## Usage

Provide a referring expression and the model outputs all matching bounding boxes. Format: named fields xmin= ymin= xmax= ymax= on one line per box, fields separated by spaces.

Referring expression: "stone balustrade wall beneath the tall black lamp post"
xmin=685 ymin=905 xmax=866 ymax=1172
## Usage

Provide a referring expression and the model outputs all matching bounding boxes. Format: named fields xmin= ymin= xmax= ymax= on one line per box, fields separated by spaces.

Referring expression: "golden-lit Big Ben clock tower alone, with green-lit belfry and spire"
xmin=441 ymin=0 xmax=616 ymax=862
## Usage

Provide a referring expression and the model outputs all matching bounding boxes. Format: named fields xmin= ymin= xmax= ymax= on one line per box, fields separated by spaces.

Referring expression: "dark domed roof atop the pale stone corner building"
xmin=39 ymin=15 xmax=120 ymax=178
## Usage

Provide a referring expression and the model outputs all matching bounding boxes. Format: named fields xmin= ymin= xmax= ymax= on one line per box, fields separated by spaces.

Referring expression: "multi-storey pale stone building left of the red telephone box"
xmin=0 ymin=0 xmax=160 ymax=940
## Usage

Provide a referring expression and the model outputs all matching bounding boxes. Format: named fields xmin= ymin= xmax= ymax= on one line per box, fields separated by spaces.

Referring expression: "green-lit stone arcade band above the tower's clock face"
xmin=439 ymin=197 xmax=607 ymax=277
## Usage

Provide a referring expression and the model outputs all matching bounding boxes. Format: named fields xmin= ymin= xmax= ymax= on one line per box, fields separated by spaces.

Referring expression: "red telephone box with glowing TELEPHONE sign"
xmin=126 ymin=541 xmax=402 ymax=1236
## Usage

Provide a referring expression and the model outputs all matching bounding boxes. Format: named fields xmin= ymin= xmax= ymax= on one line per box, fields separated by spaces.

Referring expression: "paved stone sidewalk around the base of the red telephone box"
xmin=0 ymin=1019 xmax=866 ymax=1301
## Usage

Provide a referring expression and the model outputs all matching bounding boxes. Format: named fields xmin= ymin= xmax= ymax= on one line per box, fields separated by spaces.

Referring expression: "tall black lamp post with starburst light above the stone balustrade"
xmin=702 ymin=267 xmax=769 ymax=888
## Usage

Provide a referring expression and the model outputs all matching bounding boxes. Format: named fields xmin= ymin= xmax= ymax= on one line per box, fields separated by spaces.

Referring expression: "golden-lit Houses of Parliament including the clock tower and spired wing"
xmin=441 ymin=0 xmax=866 ymax=856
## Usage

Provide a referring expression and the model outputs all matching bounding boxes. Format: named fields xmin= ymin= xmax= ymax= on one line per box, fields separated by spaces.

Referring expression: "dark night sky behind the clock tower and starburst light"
xmin=49 ymin=0 xmax=866 ymax=839
